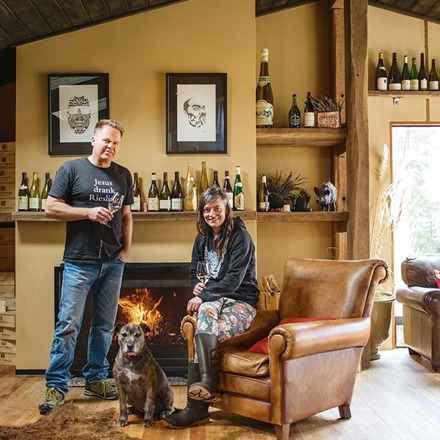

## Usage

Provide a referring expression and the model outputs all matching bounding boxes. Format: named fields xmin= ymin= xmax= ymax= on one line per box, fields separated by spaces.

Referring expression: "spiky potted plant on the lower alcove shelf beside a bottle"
xmin=260 ymin=170 xmax=306 ymax=211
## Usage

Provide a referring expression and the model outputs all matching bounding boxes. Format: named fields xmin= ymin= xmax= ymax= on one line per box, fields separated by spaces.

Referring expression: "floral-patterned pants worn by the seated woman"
xmin=196 ymin=298 xmax=257 ymax=342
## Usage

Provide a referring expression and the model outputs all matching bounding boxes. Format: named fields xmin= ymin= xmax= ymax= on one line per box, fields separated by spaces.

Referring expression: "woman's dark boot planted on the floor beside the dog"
xmin=164 ymin=362 xmax=209 ymax=429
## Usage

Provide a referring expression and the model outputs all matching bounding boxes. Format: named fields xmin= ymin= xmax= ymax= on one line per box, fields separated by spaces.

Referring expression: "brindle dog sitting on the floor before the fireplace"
xmin=113 ymin=323 xmax=174 ymax=426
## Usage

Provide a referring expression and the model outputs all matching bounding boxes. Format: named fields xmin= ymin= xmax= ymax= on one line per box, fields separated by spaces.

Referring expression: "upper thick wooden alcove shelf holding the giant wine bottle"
xmin=257 ymin=128 xmax=347 ymax=148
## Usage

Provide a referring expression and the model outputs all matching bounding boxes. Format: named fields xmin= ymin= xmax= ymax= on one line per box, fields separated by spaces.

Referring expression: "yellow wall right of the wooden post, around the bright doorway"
xmin=368 ymin=7 xmax=440 ymax=289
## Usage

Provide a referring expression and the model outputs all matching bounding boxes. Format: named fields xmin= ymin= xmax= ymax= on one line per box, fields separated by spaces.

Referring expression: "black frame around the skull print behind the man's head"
xmin=48 ymin=73 xmax=110 ymax=156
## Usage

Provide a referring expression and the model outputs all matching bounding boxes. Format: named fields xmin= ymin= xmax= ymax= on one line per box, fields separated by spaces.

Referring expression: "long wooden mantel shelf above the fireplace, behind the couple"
xmin=9 ymin=211 xmax=256 ymax=222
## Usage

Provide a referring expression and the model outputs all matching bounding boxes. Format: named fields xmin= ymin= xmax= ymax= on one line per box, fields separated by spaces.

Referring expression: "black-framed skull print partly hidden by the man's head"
xmin=48 ymin=73 xmax=109 ymax=155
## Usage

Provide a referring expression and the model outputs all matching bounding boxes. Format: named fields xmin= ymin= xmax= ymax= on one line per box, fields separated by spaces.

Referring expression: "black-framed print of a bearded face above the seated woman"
xmin=166 ymin=73 xmax=227 ymax=154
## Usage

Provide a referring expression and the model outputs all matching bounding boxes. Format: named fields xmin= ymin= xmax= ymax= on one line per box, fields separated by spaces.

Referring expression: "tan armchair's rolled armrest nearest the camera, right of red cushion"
xmin=269 ymin=318 xmax=370 ymax=360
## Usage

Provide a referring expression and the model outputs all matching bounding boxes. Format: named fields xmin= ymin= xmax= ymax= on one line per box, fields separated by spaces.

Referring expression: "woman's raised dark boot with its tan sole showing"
xmin=188 ymin=333 xmax=221 ymax=402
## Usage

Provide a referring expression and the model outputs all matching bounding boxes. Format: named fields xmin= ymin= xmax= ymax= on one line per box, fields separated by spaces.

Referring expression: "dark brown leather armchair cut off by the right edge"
xmin=396 ymin=255 xmax=440 ymax=372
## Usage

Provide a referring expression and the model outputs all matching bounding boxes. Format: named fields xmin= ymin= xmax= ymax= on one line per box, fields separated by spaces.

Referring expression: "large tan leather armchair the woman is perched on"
xmin=181 ymin=258 xmax=388 ymax=440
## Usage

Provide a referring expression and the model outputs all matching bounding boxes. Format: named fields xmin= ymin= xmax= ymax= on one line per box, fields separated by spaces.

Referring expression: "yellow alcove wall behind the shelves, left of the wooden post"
xmin=255 ymin=1 xmax=331 ymax=284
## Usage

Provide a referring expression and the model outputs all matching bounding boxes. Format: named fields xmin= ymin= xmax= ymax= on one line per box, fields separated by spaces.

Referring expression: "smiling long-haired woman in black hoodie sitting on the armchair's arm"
xmin=165 ymin=188 xmax=259 ymax=428
